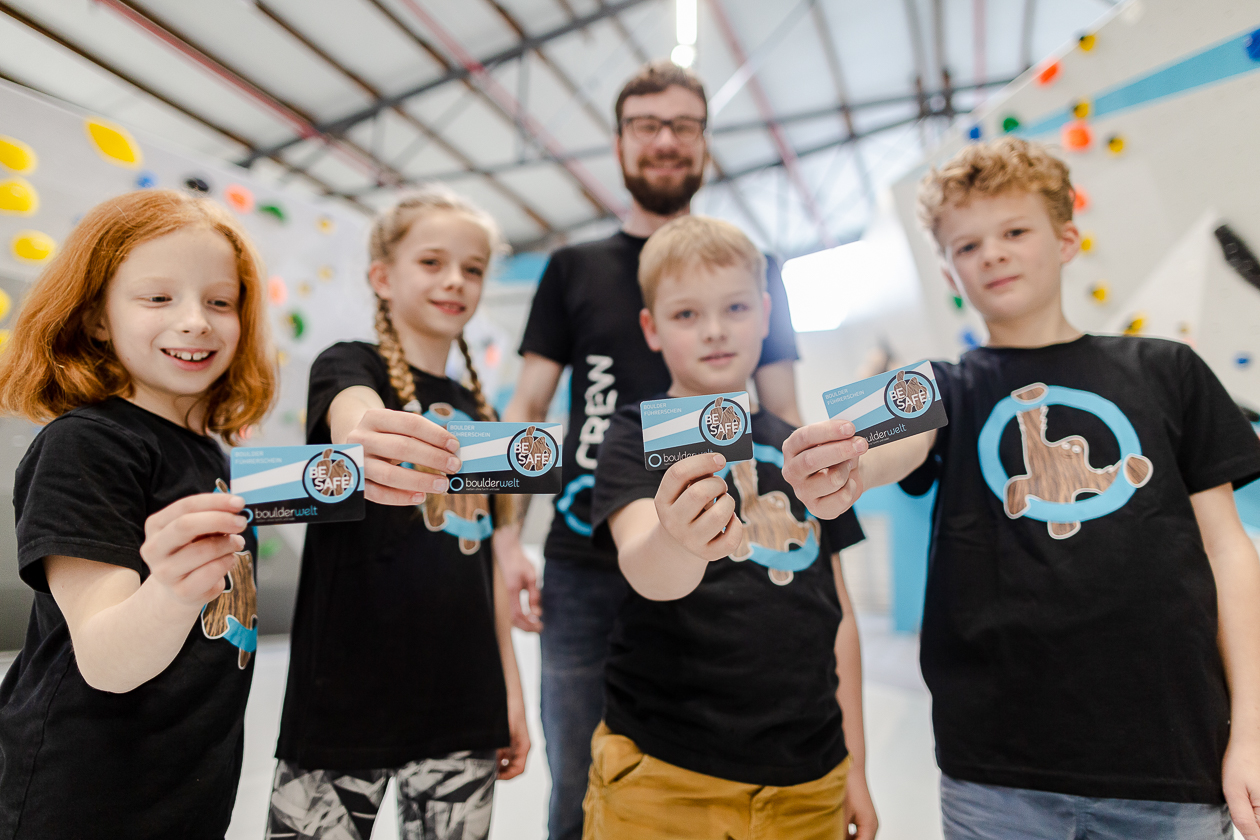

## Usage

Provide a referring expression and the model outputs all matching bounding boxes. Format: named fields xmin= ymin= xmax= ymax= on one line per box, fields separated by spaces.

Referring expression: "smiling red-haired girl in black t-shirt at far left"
xmin=0 ymin=190 xmax=276 ymax=840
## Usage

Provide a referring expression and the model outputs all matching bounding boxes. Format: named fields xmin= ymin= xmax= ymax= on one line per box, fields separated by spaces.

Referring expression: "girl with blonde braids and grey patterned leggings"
xmin=267 ymin=186 xmax=529 ymax=840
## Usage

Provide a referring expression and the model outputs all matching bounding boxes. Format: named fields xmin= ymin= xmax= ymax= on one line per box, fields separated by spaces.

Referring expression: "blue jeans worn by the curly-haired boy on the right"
xmin=941 ymin=775 xmax=1234 ymax=840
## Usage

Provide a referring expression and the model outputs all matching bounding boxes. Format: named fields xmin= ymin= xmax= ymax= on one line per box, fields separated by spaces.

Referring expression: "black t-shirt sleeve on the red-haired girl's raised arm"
xmin=13 ymin=417 xmax=154 ymax=592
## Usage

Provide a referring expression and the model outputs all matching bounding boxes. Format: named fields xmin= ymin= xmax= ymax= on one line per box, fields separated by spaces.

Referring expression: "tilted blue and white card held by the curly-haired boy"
xmin=823 ymin=361 xmax=949 ymax=446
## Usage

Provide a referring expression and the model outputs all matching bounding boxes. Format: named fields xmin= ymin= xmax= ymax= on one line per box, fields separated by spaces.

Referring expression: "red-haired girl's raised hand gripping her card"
xmin=140 ymin=492 xmax=248 ymax=607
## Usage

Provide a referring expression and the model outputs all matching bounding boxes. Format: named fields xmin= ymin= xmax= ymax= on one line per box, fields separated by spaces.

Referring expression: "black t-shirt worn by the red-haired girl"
xmin=0 ymin=398 xmax=257 ymax=840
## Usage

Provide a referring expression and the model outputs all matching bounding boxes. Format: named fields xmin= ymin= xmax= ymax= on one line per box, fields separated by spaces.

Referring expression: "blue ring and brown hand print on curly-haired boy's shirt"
xmin=977 ymin=383 xmax=1154 ymax=539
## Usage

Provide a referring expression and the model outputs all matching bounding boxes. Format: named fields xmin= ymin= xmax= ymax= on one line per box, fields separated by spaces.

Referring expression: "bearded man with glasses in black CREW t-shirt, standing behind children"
xmin=495 ymin=62 xmax=800 ymax=840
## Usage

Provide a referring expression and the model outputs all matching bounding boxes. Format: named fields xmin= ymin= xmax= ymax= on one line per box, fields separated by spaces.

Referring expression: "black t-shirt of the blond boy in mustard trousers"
xmin=592 ymin=406 xmax=862 ymax=786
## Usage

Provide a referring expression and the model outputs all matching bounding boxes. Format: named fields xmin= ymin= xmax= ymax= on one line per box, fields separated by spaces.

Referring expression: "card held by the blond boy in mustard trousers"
xmin=639 ymin=390 xmax=752 ymax=470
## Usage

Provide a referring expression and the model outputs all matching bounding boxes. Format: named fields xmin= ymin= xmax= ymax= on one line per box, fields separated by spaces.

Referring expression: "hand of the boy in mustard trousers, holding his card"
xmin=655 ymin=455 xmax=743 ymax=562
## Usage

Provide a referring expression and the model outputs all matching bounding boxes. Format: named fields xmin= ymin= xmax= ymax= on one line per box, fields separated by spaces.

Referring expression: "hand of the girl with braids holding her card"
xmin=345 ymin=408 xmax=460 ymax=505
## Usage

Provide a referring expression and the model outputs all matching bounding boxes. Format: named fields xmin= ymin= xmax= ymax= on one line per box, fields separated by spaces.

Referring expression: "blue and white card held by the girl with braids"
xmin=446 ymin=421 xmax=564 ymax=494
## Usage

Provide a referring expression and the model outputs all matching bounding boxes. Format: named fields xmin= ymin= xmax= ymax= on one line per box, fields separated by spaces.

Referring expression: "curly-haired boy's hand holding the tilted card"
xmin=784 ymin=419 xmax=868 ymax=519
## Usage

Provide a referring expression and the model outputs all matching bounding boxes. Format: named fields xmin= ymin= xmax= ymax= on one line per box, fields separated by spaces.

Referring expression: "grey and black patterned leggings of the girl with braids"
xmin=267 ymin=749 xmax=498 ymax=840
